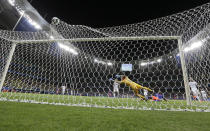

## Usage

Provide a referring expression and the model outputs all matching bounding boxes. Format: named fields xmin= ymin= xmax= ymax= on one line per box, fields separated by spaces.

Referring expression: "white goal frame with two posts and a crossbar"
xmin=0 ymin=36 xmax=192 ymax=105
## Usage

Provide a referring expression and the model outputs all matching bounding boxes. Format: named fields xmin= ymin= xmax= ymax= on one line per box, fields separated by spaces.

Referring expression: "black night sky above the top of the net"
xmin=29 ymin=0 xmax=210 ymax=27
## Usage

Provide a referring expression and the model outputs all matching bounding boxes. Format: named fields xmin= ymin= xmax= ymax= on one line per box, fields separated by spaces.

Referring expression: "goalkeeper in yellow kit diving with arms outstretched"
xmin=117 ymin=75 xmax=152 ymax=99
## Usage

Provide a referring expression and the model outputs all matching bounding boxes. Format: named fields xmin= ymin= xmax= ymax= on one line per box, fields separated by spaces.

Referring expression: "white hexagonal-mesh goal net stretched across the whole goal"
xmin=0 ymin=3 xmax=210 ymax=111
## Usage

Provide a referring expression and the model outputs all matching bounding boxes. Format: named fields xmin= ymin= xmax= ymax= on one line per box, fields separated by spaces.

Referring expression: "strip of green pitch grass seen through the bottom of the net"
xmin=0 ymin=93 xmax=210 ymax=110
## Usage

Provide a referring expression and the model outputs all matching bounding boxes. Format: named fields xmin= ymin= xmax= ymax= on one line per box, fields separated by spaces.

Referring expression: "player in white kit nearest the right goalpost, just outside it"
xmin=189 ymin=77 xmax=201 ymax=101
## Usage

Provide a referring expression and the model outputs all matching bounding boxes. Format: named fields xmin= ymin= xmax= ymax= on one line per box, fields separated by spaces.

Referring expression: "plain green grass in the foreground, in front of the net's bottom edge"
xmin=0 ymin=102 xmax=210 ymax=131
